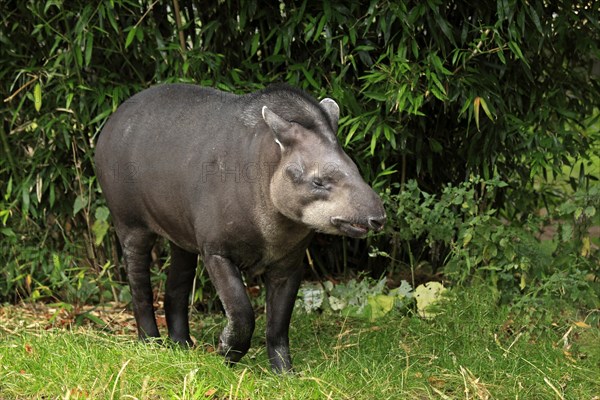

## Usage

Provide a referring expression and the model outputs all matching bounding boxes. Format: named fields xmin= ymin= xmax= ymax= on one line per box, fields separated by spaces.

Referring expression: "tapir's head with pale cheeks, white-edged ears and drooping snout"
xmin=262 ymin=94 xmax=386 ymax=237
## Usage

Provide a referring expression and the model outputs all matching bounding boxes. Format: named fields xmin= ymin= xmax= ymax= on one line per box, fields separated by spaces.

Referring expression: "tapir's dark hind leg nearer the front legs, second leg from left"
xmin=165 ymin=242 xmax=198 ymax=346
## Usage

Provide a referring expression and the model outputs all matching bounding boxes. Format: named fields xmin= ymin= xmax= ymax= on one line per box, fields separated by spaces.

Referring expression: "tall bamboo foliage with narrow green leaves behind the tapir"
xmin=0 ymin=0 xmax=600 ymax=297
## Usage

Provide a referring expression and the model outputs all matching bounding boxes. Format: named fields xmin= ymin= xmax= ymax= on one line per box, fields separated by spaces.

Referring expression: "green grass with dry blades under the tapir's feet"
xmin=0 ymin=288 xmax=600 ymax=399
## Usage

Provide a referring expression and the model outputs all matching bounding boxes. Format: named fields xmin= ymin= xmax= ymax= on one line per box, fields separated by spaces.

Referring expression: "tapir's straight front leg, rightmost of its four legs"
xmin=266 ymin=262 xmax=302 ymax=373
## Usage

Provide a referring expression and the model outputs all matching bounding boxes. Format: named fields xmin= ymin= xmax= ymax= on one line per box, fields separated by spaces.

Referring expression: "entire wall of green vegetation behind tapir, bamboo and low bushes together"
xmin=0 ymin=0 xmax=600 ymax=307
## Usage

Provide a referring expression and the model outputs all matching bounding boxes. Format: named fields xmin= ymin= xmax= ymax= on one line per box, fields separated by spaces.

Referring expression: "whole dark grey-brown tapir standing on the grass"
xmin=95 ymin=84 xmax=385 ymax=372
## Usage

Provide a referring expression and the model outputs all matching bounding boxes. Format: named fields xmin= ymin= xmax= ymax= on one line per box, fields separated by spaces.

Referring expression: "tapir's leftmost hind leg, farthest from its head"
xmin=117 ymin=229 xmax=160 ymax=340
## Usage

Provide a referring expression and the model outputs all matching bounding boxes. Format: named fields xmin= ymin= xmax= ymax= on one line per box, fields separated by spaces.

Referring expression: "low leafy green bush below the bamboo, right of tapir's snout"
xmin=374 ymin=178 xmax=600 ymax=307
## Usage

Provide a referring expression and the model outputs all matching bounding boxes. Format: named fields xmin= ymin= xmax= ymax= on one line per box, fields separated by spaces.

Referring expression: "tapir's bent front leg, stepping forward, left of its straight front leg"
xmin=204 ymin=255 xmax=254 ymax=362
